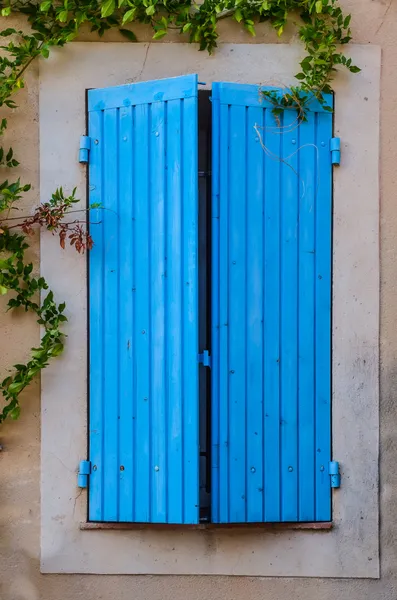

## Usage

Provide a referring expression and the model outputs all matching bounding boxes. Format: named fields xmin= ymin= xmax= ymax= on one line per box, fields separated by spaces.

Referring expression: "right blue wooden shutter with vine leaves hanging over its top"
xmin=212 ymin=83 xmax=332 ymax=523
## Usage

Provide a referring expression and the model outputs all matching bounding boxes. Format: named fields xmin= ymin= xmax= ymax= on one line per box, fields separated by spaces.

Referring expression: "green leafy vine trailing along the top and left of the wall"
xmin=0 ymin=0 xmax=360 ymax=423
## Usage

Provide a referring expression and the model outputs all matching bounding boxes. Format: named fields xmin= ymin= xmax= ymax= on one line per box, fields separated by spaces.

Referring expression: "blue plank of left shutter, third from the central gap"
xmin=149 ymin=102 xmax=167 ymax=523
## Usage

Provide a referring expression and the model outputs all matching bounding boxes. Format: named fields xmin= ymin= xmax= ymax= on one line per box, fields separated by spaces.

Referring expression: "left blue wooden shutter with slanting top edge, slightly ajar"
xmin=88 ymin=75 xmax=199 ymax=523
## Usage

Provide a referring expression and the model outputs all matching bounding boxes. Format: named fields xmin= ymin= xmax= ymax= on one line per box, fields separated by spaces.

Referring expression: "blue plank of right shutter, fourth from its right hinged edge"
xmin=262 ymin=109 xmax=283 ymax=522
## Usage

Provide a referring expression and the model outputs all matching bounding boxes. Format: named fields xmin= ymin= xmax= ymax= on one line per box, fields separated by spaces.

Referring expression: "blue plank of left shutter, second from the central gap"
xmin=165 ymin=100 xmax=183 ymax=523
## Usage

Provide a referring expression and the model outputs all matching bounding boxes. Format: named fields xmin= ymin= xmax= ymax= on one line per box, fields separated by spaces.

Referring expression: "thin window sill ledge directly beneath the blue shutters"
xmin=80 ymin=521 xmax=334 ymax=531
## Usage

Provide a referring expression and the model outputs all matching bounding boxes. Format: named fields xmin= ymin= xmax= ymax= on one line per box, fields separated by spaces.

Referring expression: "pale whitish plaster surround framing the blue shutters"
xmin=40 ymin=42 xmax=380 ymax=578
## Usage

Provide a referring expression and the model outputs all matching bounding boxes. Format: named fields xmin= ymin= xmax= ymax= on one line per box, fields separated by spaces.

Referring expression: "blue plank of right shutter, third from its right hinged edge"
xmin=278 ymin=111 xmax=299 ymax=521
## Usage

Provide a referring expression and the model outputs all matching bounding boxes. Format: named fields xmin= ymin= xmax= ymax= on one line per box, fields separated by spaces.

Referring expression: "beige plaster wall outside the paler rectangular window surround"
xmin=0 ymin=0 xmax=397 ymax=600
